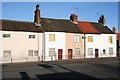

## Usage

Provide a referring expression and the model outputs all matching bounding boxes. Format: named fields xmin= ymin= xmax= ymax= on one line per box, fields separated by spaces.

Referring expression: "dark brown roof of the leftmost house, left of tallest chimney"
xmin=0 ymin=20 xmax=42 ymax=32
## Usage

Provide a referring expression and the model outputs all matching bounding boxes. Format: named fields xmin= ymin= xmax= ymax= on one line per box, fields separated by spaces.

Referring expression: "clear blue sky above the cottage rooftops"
xmin=2 ymin=2 xmax=118 ymax=30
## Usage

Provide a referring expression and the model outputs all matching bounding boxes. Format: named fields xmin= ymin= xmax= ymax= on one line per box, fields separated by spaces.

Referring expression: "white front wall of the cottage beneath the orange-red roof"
xmin=85 ymin=34 xmax=116 ymax=58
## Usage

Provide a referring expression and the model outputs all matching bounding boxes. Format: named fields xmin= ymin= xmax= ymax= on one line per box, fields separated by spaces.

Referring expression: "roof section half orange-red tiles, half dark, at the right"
xmin=78 ymin=21 xmax=114 ymax=34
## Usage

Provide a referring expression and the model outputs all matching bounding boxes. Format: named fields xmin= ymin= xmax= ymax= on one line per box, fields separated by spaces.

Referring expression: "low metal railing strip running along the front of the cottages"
xmin=0 ymin=53 xmax=120 ymax=63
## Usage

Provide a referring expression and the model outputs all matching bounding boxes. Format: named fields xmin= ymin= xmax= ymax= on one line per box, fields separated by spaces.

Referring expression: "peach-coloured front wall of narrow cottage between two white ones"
xmin=65 ymin=33 xmax=84 ymax=59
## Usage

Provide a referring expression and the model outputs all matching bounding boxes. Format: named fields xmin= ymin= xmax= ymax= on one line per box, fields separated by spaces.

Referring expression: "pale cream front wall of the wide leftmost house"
xmin=0 ymin=31 xmax=42 ymax=62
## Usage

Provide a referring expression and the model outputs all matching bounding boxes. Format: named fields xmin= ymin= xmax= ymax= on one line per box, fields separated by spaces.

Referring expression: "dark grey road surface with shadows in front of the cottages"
xmin=2 ymin=58 xmax=120 ymax=80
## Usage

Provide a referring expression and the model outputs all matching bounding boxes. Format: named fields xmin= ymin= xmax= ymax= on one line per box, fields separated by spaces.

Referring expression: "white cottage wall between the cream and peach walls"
xmin=45 ymin=32 xmax=65 ymax=61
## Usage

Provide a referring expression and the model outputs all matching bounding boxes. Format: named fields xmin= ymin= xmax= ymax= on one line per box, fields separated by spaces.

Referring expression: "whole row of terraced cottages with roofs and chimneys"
xmin=0 ymin=5 xmax=116 ymax=63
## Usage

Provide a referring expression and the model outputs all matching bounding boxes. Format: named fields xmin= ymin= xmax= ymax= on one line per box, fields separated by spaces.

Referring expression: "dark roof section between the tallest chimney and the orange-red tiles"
xmin=41 ymin=18 xmax=82 ymax=33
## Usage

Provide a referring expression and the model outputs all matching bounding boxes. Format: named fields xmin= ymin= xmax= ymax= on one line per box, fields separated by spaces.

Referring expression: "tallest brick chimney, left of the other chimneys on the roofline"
xmin=34 ymin=5 xmax=41 ymax=27
